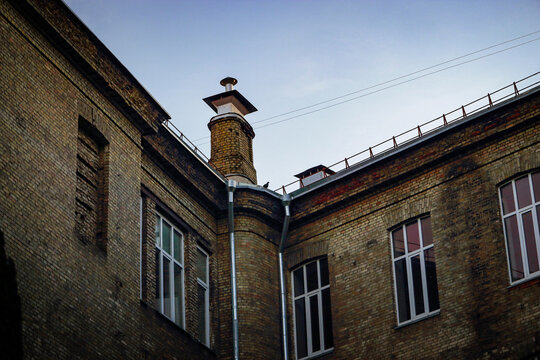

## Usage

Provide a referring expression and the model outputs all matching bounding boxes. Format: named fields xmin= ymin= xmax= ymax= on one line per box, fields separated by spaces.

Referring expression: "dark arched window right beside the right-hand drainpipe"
xmin=292 ymin=258 xmax=334 ymax=359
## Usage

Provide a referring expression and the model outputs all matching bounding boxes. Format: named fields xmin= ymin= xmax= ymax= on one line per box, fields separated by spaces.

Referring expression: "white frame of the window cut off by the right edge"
xmin=498 ymin=171 xmax=540 ymax=286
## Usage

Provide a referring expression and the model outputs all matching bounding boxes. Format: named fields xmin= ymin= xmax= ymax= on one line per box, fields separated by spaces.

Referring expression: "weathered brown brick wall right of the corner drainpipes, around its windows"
xmin=286 ymin=94 xmax=540 ymax=359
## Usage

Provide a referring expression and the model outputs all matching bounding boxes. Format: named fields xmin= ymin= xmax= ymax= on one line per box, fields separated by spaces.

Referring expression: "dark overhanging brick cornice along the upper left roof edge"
xmin=8 ymin=0 xmax=170 ymax=134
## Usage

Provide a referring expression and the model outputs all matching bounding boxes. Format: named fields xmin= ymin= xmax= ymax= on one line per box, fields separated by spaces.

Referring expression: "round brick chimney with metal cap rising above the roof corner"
xmin=203 ymin=77 xmax=257 ymax=184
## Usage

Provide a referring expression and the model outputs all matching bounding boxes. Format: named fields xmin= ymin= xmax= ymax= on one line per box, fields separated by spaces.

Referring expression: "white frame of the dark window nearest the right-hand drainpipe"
xmin=291 ymin=257 xmax=334 ymax=360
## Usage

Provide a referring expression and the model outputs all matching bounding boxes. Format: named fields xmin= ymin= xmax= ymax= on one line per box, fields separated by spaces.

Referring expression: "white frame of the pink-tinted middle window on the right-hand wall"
xmin=390 ymin=214 xmax=441 ymax=327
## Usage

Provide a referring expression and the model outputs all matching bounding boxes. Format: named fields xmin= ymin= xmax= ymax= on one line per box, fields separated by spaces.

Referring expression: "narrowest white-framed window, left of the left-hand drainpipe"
xmin=196 ymin=247 xmax=210 ymax=346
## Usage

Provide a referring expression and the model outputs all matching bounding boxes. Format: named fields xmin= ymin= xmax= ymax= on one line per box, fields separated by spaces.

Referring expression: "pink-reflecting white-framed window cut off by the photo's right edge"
xmin=499 ymin=172 xmax=540 ymax=283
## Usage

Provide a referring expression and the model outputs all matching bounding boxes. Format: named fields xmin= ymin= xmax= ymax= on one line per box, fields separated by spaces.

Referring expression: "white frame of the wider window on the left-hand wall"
xmin=154 ymin=210 xmax=186 ymax=329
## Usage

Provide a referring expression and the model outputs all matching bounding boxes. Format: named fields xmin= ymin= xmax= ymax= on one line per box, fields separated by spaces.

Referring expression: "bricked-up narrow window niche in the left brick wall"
xmin=75 ymin=119 xmax=107 ymax=249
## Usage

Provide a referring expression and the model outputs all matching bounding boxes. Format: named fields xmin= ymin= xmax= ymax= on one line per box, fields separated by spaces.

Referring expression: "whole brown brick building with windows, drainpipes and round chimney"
xmin=0 ymin=0 xmax=540 ymax=359
